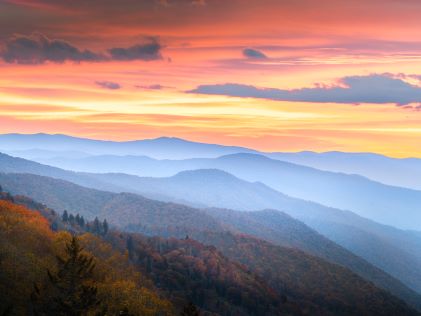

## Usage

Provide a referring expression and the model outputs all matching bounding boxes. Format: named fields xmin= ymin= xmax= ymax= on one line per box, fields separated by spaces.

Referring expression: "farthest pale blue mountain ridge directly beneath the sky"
xmin=0 ymin=133 xmax=421 ymax=190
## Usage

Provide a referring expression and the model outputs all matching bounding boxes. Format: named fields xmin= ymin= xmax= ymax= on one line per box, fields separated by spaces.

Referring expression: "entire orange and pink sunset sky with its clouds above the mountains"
xmin=0 ymin=0 xmax=421 ymax=157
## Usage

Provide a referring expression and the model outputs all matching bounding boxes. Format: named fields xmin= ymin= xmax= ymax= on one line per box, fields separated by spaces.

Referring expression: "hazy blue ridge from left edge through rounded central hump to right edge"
xmin=0 ymin=151 xmax=421 ymax=291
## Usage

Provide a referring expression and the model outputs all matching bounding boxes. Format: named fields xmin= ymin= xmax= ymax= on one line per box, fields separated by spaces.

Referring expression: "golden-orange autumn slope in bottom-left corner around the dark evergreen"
xmin=0 ymin=201 xmax=175 ymax=316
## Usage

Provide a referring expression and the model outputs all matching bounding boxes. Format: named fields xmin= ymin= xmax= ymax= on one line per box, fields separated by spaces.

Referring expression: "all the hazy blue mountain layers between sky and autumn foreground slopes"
xmin=0 ymin=134 xmax=421 ymax=309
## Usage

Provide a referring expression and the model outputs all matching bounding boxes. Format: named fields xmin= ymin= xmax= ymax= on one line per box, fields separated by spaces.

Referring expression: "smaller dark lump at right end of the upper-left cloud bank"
xmin=108 ymin=38 xmax=162 ymax=61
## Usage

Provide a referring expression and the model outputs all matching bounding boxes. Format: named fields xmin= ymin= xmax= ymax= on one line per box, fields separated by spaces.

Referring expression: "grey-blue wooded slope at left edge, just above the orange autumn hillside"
xmin=0 ymin=174 xmax=223 ymax=230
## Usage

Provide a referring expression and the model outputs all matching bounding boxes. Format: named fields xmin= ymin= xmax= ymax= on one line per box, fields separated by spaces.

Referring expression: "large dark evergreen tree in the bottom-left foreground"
xmin=32 ymin=237 xmax=100 ymax=316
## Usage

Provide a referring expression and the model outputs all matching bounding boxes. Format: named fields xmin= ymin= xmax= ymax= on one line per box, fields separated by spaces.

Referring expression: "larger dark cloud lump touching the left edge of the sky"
xmin=1 ymin=33 xmax=104 ymax=64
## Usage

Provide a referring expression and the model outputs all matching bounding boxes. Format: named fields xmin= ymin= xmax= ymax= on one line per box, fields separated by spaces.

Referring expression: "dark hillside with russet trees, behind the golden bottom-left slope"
xmin=1 ymin=185 xmax=416 ymax=315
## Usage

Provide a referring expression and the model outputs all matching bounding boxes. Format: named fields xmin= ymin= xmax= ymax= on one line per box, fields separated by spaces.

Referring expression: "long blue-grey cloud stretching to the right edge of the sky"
xmin=189 ymin=74 xmax=421 ymax=106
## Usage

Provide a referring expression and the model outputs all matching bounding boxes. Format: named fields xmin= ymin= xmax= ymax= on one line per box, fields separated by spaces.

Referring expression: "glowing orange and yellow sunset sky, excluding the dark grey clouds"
xmin=0 ymin=0 xmax=421 ymax=157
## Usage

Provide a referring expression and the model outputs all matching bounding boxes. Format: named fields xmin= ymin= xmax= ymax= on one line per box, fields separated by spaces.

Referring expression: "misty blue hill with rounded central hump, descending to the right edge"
xmin=85 ymin=170 xmax=421 ymax=292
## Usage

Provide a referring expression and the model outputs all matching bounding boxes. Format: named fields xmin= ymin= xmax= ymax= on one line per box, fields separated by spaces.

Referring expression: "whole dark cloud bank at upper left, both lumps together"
xmin=0 ymin=33 xmax=162 ymax=64
